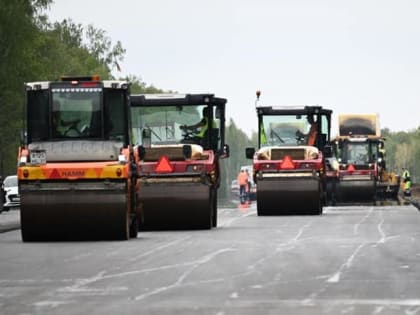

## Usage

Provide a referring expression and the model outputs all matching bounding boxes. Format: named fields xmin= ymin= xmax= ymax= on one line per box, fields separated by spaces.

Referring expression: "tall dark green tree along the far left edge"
xmin=0 ymin=0 xmax=51 ymax=176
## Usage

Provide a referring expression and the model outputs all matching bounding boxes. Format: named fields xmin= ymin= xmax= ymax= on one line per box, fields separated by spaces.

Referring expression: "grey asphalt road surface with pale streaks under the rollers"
xmin=0 ymin=205 xmax=420 ymax=315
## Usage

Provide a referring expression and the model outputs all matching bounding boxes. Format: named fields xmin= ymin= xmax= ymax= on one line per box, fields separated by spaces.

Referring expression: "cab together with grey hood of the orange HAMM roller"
xmin=19 ymin=76 xmax=130 ymax=166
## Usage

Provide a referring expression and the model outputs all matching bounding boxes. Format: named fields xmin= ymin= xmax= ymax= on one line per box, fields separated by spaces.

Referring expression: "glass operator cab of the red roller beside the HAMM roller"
xmin=131 ymin=94 xmax=227 ymax=155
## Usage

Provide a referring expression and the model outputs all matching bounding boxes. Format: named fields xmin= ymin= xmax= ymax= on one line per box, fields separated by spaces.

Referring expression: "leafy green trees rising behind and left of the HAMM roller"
xmin=0 ymin=0 xmax=125 ymax=176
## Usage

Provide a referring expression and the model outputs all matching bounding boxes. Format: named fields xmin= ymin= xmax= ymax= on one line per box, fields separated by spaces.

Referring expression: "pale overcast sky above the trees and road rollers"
xmin=48 ymin=0 xmax=420 ymax=134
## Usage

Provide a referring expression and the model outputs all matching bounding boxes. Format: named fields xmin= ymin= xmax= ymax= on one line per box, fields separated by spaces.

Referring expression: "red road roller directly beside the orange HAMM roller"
xmin=131 ymin=94 xmax=229 ymax=229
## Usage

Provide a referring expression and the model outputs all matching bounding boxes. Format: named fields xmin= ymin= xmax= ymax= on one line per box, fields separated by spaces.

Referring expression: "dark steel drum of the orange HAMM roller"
xmin=20 ymin=183 xmax=129 ymax=241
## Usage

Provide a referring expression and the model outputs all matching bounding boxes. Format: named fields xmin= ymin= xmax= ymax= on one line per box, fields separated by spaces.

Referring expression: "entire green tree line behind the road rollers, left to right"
xmin=0 ymin=0 xmax=420 ymax=197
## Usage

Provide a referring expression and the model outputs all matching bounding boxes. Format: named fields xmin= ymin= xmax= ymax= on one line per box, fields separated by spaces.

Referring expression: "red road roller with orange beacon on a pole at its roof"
xmin=246 ymin=92 xmax=332 ymax=215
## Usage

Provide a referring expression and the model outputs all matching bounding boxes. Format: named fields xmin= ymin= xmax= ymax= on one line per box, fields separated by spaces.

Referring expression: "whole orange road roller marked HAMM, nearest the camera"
xmin=17 ymin=76 xmax=141 ymax=242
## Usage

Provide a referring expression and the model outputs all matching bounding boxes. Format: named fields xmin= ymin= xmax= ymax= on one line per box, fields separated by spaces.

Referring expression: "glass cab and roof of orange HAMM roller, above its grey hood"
xmin=26 ymin=76 xmax=129 ymax=144
